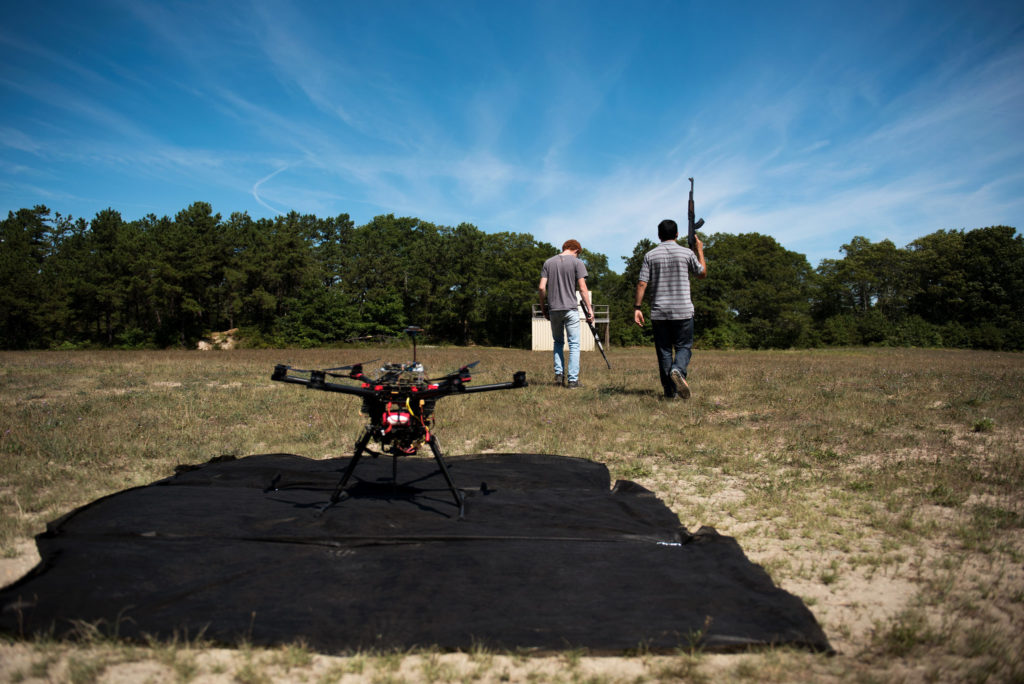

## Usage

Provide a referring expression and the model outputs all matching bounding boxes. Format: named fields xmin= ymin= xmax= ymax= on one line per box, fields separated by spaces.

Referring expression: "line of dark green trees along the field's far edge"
xmin=0 ymin=203 xmax=1024 ymax=349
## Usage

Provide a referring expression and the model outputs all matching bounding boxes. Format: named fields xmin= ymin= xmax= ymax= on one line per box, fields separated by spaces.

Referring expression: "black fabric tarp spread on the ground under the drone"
xmin=0 ymin=454 xmax=831 ymax=653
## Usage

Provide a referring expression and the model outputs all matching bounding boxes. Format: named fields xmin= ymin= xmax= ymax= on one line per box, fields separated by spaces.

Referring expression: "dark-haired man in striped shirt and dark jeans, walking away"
xmin=633 ymin=218 xmax=708 ymax=399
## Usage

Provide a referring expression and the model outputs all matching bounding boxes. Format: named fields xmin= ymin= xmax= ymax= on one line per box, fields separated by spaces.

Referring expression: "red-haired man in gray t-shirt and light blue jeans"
xmin=537 ymin=240 xmax=594 ymax=388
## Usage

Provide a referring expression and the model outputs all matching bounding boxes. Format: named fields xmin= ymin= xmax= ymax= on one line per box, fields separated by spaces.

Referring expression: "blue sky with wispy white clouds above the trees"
xmin=0 ymin=0 xmax=1024 ymax=271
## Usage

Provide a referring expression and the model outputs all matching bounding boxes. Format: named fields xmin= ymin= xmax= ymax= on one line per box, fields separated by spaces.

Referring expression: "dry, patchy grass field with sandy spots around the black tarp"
xmin=0 ymin=347 xmax=1024 ymax=682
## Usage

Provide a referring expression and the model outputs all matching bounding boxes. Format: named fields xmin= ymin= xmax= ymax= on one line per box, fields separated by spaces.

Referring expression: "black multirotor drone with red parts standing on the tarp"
xmin=270 ymin=331 xmax=527 ymax=518
